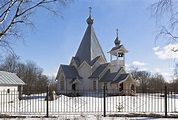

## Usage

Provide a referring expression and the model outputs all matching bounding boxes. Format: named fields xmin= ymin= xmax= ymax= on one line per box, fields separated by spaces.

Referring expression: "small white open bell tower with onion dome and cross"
xmin=108 ymin=29 xmax=128 ymax=73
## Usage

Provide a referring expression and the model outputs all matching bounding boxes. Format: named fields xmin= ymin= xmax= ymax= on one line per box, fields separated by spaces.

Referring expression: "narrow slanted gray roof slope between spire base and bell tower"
xmin=89 ymin=63 xmax=109 ymax=78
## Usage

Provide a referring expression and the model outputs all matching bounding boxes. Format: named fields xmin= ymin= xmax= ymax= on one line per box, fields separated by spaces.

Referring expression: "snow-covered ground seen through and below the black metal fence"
xmin=0 ymin=94 xmax=178 ymax=120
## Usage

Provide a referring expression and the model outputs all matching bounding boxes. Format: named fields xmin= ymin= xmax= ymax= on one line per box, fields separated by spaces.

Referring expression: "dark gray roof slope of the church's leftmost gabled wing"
xmin=61 ymin=65 xmax=82 ymax=79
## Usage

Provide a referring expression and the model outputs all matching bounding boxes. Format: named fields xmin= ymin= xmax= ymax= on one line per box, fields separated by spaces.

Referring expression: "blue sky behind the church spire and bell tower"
xmin=13 ymin=0 xmax=176 ymax=80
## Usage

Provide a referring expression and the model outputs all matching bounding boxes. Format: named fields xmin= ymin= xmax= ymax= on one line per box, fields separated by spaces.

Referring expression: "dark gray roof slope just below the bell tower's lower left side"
xmin=100 ymin=69 xmax=118 ymax=82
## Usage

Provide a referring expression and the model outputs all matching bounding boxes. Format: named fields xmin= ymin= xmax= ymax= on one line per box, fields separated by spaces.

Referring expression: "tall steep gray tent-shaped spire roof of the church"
xmin=75 ymin=17 xmax=106 ymax=65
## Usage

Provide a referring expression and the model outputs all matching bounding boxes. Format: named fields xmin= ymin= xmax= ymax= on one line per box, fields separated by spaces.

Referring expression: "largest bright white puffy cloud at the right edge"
xmin=153 ymin=43 xmax=178 ymax=59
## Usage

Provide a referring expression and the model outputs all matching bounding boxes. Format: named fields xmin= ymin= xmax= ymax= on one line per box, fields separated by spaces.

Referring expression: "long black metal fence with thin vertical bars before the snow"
xmin=0 ymin=87 xmax=178 ymax=116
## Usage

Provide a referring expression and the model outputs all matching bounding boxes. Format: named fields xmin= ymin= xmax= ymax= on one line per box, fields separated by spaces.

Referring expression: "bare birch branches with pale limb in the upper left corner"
xmin=0 ymin=0 xmax=71 ymax=52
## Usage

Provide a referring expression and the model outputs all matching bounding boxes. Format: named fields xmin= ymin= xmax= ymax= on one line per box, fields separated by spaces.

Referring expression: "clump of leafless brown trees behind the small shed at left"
xmin=0 ymin=55 xmax=52 ymax=94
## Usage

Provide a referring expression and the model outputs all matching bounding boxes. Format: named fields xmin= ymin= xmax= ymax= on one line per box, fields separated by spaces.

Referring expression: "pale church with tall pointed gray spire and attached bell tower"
xmin=56 ymin=11 xmax=138 ymax=95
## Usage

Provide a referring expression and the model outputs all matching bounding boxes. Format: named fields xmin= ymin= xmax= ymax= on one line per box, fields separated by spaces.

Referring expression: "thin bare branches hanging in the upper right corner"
xmin=151 ymin=0 xmax=178 ymax=45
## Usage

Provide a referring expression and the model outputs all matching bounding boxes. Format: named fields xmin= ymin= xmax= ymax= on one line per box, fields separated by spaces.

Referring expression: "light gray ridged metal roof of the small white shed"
xmin=0 ymin=71 xmax=25 ymax=86
